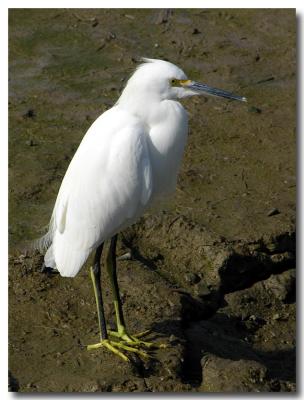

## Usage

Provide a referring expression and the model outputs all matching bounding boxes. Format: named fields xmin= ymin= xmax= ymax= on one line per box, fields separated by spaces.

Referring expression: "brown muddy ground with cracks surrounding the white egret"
xmin=9 ymin=9 xmax=296 ymax=392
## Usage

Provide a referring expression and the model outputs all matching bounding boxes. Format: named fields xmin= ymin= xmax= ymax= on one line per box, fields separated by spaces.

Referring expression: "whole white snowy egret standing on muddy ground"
xmin=38 ymin=59 xmax=246 ymax=360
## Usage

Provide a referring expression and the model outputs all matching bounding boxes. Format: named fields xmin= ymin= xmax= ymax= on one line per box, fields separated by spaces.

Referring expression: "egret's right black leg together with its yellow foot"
xmin=106 ymin=235 xmax=166 ymax=347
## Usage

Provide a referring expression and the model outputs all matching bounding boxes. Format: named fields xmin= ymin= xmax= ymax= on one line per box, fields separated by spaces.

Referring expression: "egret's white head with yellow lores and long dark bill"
xmin=117 ymin=58 xmax=246 ymax=101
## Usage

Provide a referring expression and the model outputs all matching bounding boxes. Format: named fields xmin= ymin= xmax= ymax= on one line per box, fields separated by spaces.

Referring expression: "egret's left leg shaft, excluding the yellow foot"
xmin=91 ymin=243 xmax=108 ymax=340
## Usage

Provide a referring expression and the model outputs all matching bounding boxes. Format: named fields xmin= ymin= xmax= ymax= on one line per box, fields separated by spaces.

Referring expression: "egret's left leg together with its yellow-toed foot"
xmin=87 ymin=244 xmax=147 ymax=361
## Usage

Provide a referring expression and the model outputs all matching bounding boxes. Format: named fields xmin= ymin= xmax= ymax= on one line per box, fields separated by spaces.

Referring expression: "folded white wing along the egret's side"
xmin=51 ymin=108 xmax=152 ymax=276
